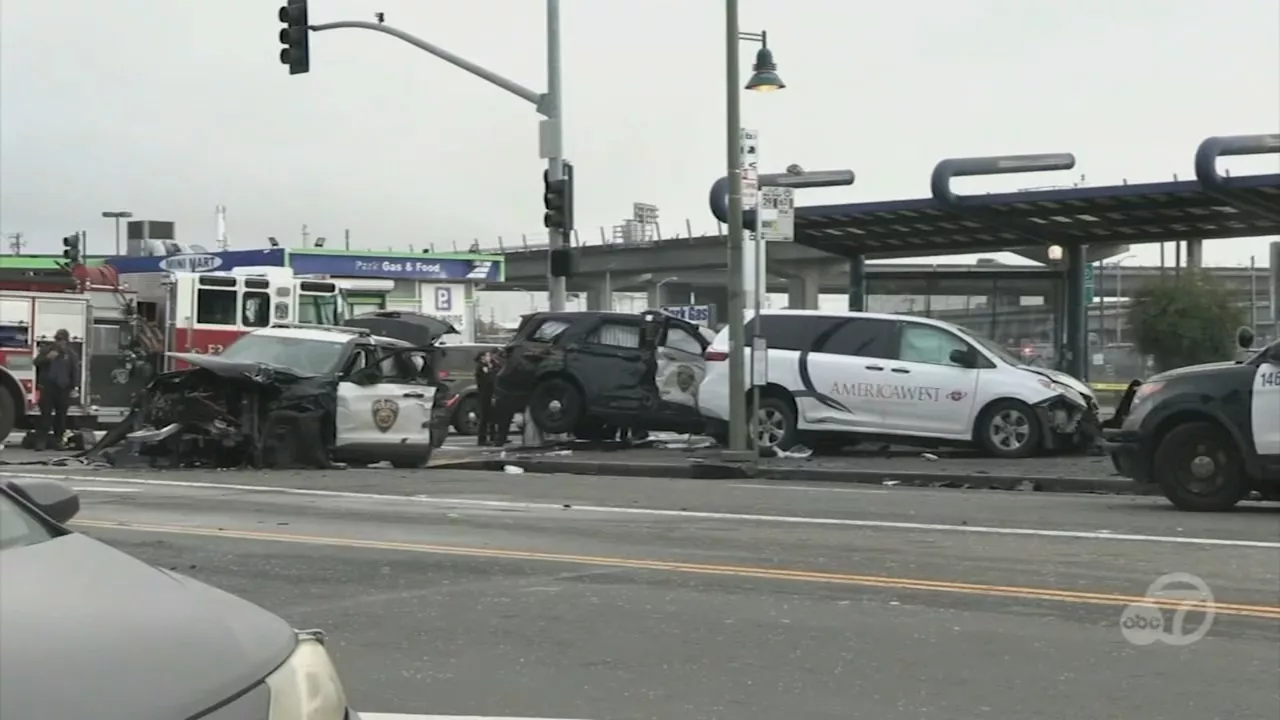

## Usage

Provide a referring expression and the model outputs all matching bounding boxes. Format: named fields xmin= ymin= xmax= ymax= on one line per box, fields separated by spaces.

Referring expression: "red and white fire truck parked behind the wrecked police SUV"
xmin=0 ymin=260 xmax=343 ymax=442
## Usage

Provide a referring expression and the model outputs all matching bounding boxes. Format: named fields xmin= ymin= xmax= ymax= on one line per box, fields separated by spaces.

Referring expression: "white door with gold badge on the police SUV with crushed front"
xmin=337 ymin=380 xmax=435 ymax=451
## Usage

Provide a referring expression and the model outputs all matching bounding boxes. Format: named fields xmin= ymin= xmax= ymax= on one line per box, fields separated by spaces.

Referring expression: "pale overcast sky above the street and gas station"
xmin=0 ymin=0 xmax=1280 ymax=315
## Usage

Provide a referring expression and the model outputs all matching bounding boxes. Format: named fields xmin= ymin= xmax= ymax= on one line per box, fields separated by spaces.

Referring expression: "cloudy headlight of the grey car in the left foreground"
xmin=266 ymin=630 xmax=347 ymax=720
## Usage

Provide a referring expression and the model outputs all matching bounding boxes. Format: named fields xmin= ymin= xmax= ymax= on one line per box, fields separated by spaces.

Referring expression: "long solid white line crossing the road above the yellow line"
xmin=0 ymin=473 xmax=1280 ymax=550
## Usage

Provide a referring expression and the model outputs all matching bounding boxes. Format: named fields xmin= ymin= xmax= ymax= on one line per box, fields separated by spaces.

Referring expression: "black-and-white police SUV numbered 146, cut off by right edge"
xmin=1102 ymin=328 xmax=1280 ymax=511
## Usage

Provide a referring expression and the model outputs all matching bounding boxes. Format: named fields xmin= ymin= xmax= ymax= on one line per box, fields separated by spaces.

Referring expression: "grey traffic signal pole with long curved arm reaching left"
xmin=308 ymin=0 xmax=568 ymax=311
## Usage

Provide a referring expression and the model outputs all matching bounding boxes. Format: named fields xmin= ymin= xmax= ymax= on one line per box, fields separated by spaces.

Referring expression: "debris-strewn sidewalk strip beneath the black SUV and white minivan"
xmin=438 ymin=445 xmax=1147 ymax=493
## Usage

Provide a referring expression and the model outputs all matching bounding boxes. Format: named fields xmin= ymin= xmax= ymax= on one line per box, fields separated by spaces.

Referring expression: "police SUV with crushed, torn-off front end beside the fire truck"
xmin=111 ymin=324 xmax=457 ymax=468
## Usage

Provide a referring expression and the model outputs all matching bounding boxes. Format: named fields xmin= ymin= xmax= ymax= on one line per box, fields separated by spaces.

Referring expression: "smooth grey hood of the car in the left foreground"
xmin=0 ymin=534 xmax=297 ymax=720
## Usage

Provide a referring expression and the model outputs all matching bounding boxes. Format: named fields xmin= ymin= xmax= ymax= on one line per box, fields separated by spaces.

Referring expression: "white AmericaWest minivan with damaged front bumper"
xmin=699 ymin=310 xmax=1098 ymax=457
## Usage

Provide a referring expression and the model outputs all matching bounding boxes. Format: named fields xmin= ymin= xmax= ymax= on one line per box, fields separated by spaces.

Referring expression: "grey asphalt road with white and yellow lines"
xmin=0 ymin=466 xmax=1280 ymax=720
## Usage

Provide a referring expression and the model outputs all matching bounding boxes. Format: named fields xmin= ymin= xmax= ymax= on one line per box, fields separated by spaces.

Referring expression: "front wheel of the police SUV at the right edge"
xmin=1152 ymin=423 xmax=1249 ymax=512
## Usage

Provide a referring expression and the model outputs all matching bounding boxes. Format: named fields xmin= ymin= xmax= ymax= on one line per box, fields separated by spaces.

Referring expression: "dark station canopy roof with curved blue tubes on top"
xmin=795 ymin=136 xmax=1280 ymax=255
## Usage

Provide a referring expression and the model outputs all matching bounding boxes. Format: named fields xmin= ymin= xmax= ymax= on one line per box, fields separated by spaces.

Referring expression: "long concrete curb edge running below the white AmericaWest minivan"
xmin=433 ymin=457 xmax=1158 ymax=495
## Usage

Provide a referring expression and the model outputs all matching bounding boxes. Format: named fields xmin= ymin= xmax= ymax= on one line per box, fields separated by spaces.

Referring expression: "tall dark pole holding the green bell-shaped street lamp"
xmin=724 ymin=0 xmax=748 ymax=451
